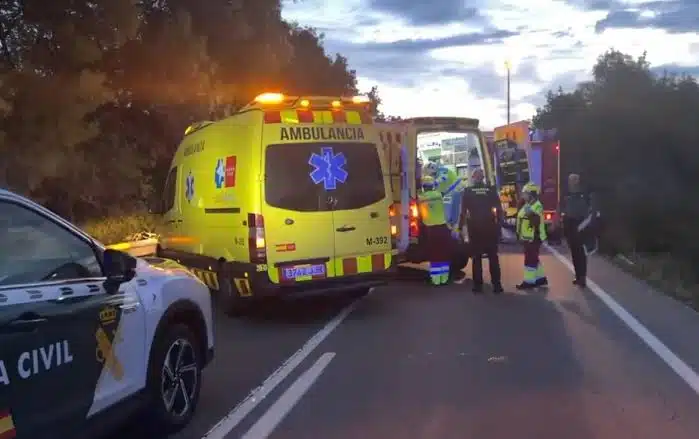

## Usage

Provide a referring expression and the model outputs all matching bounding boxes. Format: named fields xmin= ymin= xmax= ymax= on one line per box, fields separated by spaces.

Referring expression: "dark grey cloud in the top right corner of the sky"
xmin=595 ymin=0 xmax=699 ymax=33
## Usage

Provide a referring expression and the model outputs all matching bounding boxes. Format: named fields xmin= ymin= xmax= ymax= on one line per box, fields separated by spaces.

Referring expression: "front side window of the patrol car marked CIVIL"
xmin=0 ymin=201 xmax=103 ymax=286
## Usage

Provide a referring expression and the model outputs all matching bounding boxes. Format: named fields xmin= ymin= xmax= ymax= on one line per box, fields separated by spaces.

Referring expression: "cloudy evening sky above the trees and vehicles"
xmin=283 ymin=0 xmax=699 ymax=129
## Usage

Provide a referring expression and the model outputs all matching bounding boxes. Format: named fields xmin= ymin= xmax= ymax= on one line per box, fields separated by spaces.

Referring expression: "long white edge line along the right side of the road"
xmin=546 ymin=244 xmax=699 ymax=394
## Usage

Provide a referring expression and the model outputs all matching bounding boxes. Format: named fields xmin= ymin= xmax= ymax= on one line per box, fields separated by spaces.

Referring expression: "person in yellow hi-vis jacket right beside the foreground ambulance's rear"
xmin=418 ymin=175 xmax=453 ymax=285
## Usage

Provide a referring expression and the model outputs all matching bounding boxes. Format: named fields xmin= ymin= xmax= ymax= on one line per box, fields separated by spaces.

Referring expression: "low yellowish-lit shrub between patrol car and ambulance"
xmin=82 ymin=214 xmax=161 ymax=245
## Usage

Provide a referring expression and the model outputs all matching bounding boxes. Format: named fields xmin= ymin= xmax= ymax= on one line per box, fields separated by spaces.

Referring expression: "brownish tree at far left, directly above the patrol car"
xmin=0 ymin=0 xmax=137 ymax=216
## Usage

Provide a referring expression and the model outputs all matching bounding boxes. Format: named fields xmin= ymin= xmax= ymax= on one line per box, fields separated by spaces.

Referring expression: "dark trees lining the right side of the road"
xmin=533 ymin=50 xmax=699 ymax=267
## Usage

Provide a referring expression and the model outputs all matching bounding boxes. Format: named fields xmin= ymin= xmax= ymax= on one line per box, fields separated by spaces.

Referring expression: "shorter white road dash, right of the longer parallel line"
xmin=241 ymin=352 xmax=335 ymax=439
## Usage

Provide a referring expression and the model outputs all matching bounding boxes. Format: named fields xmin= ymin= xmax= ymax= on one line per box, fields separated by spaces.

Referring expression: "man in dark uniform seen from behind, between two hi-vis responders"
xmin=459 ymin=169 xmax=503 ymax=294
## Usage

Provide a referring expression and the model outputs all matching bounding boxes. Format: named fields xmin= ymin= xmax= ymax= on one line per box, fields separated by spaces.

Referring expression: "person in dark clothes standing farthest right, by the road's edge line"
xmin=560 ymin=174 xmax=593 ymax=288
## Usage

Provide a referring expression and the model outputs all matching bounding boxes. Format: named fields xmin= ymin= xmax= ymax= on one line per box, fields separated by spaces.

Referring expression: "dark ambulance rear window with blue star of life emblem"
xmin=265 ymin=142 xmax=386 ymax=212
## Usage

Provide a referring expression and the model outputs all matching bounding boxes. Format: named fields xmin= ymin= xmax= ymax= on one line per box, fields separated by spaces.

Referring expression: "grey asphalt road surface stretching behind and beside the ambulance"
xmin=118 ymin=246 xmax=699 ymax=439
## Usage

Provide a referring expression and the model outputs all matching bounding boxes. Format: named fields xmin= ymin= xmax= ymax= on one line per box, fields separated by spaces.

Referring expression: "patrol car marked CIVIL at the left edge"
xmin=0 ymin=189 xmax=214 ymax=439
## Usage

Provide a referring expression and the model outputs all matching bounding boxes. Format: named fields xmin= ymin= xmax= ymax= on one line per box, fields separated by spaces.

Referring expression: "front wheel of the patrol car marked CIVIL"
xmin=148 ymin=324 xmax=202 ymax=433
